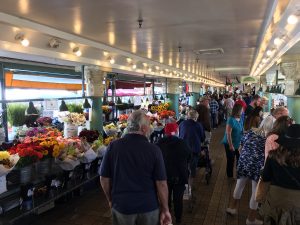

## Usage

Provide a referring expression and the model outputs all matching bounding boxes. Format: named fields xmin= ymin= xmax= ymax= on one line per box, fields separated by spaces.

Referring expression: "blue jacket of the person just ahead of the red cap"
xmin=179 ymin=119 xmax=205 ymax=153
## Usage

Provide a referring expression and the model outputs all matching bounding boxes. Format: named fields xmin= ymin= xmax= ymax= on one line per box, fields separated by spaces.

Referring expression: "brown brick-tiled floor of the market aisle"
xmin=32 ymin=127 xmax=251 ymax=225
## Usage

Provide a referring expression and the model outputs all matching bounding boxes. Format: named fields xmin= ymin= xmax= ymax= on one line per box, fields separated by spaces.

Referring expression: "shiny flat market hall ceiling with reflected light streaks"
xmin=0 ymin=0 xmax=289 ymax=84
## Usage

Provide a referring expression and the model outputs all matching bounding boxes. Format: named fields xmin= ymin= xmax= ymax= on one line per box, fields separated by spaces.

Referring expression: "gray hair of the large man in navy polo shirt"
xmin=127 ymin=110 xmax=149 ymax=133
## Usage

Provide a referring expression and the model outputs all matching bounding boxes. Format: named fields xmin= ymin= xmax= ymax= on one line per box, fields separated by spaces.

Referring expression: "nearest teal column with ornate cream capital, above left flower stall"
xmin=84 ymin=66 xmax=106 ymax=133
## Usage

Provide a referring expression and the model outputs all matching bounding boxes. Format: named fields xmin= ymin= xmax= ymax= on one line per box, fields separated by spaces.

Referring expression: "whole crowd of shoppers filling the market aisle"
xmin=100 ymin=90 xmax=300 ymax=225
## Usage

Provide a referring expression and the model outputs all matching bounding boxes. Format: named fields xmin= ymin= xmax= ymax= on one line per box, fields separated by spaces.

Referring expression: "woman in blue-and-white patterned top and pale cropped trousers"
xmin=226 ymin=128 xmax=266 ymax=225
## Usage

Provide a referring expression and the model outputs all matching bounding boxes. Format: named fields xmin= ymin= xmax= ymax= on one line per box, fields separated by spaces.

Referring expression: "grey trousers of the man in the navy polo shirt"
xmin=112 ymin=208 xmax=159 ymax=225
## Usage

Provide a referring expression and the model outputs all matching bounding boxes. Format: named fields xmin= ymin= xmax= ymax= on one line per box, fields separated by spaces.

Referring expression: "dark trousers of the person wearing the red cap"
xmin=168 ymin=179 xmax=185 ymax=222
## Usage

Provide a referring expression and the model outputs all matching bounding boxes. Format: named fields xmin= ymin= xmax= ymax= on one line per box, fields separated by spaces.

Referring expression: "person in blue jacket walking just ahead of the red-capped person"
xmin=179 ymin=110 xmax=205 ymax=192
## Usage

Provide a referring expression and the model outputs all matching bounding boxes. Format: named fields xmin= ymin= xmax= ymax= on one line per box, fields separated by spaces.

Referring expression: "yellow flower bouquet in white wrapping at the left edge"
xmin=0 ymin=151 xmax=19 ymax=194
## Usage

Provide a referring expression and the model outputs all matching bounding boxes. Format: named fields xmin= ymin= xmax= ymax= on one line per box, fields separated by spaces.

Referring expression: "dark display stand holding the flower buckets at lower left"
xmin=0 ymin=160 xmax=101 ymax=225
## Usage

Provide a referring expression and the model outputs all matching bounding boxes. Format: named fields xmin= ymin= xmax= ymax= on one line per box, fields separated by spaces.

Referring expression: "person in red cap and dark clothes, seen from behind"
xmin=157 ymin=123 xmax=191 ymax=224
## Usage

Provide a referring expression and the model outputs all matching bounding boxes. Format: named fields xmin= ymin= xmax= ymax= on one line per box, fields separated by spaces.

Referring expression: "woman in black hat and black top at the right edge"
xmin=261 ymin=124 xmax=300 ymax=225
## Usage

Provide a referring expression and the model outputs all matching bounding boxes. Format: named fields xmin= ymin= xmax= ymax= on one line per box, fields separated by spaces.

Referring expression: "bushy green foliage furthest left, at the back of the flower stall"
xmin=7 ymin=103 xmax=27 ymax=127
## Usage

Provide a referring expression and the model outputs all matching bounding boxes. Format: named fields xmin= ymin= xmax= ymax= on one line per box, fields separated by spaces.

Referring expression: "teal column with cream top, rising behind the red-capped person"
xmin=167 ymin=79 xmax=180 ymax=118
